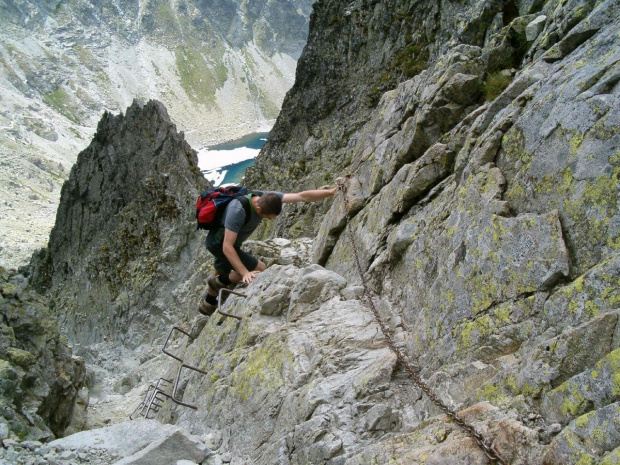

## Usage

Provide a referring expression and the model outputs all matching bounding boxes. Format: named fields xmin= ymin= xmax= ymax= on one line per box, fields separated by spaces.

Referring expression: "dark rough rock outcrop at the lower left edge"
xmin=0 ymin=269 xmax=86 ymax=440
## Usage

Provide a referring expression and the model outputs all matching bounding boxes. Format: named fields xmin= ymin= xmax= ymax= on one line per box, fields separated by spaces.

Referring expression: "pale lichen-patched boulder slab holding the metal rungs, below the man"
xmin=159 ymin=265 xmax=543 ymax=465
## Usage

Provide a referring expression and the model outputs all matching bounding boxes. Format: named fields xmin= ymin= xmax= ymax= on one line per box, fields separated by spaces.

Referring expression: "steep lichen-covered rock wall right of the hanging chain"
xmin=224 ymin=1 xmax=620 ymax=464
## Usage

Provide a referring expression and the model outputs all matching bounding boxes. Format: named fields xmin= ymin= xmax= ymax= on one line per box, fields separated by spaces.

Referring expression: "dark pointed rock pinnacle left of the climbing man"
xmin=34 ymin=101 xmax=211 ymax=347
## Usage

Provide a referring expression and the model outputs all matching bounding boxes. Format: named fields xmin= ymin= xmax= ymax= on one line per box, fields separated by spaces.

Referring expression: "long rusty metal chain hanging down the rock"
xmin=338 ymin=181 xmax=506 ymax=465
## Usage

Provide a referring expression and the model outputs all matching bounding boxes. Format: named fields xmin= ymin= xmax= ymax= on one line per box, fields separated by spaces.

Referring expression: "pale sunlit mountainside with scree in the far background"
xmin=0 ymin=0 xmax=312 ymax=267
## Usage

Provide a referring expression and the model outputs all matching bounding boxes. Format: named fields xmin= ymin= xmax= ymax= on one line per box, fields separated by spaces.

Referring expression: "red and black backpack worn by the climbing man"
xmin=196 ymin=186 xmax=251 ymax=230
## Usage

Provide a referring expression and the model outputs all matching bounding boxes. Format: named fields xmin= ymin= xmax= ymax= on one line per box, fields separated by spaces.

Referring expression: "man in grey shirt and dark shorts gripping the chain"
xmin=198 ymin=187 xmax=338 ymax=316
